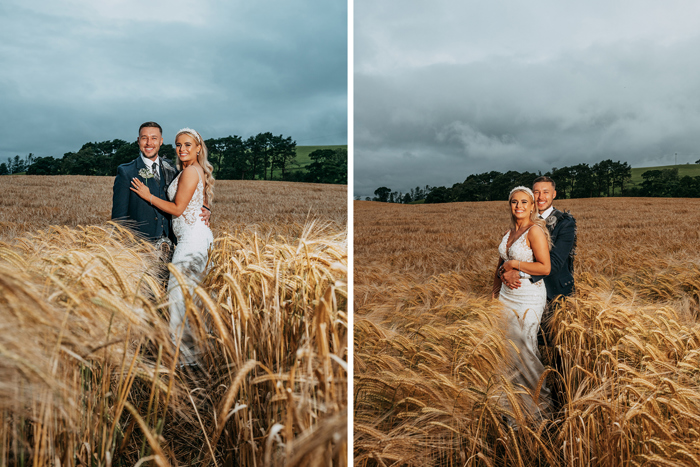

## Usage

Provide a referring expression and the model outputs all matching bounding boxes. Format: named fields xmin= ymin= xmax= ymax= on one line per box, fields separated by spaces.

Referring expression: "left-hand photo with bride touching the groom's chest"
xmin=0 ymin=0 xmax=351 ymax=466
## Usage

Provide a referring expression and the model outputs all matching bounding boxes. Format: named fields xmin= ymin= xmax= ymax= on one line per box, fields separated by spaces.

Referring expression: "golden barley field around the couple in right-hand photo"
xmin=353 ymin=198 xmax=700 ymax=466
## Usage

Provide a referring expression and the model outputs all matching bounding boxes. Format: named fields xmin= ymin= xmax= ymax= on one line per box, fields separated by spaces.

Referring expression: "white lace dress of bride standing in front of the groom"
xmin=498 ymin=226 xmax=549 ymax=416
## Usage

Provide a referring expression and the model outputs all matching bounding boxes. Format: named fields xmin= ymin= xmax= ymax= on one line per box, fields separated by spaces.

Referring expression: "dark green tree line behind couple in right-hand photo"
xmin=366 ymin=159 xmax=700 ymax=204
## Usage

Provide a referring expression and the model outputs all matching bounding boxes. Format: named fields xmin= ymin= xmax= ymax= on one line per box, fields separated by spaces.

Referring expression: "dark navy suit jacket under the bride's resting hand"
xmin=112 ymin=155 xmax=177 ymax=242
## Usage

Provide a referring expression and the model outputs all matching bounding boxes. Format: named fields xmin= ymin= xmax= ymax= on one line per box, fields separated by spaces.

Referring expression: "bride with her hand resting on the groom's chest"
xmin=131 ymin=128 xmax=214 ymax=365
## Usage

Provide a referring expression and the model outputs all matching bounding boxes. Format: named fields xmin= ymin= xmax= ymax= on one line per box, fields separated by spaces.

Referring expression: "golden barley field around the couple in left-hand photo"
xmin=0 ymin=176 xmax=348 ymax=466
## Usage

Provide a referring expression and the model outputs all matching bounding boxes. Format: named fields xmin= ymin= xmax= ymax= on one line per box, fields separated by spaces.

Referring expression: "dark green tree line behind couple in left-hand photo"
xmin=0 ymin=132 xmax=347 ymax=184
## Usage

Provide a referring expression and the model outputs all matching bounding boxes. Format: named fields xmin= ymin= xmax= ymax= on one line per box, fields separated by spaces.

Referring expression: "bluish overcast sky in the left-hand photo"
xmin=0 ymin=0 xmax=347 ymax=162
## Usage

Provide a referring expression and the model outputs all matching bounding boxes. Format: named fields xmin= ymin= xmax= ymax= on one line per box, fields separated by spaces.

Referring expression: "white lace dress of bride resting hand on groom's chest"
xmin=168 ymin=172 xmax=214 ymax=364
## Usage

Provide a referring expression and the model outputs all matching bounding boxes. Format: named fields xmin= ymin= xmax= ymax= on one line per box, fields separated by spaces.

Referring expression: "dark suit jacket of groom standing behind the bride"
xmin=532 ymin=208 xmax=576 ymax=300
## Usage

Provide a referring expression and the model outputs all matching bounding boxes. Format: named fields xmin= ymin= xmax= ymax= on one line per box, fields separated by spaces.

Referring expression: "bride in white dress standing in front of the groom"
xmin=492 ymin=186 xmax=551 ymax=418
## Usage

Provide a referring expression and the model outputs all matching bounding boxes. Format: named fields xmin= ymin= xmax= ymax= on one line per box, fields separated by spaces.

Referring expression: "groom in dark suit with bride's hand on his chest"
xmin=112 ymin=122 xmax=211 ymax=243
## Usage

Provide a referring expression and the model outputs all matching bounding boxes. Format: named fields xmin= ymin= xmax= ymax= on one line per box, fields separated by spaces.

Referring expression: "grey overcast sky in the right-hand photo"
xmin=354 ymin=0 xmax=700 ymax=197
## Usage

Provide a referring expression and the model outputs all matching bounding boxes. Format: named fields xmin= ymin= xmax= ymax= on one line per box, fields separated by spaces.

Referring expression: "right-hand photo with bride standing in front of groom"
xmin=352 ymin=0 xmax=700 ymax=467
